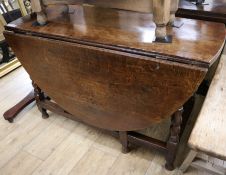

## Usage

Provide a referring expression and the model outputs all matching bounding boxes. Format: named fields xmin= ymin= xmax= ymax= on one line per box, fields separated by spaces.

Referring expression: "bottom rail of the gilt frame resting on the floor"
xmin=0 ymin=58 xmax=21 ymax=78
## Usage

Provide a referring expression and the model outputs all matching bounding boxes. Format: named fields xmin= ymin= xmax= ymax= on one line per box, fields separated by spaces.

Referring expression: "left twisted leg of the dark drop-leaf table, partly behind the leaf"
xmin=32 ymin=82 xmax=49 ymax=119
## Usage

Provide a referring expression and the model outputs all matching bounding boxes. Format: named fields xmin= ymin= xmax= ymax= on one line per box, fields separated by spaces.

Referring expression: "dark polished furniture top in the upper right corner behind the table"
xmin=176 ymin=0 xmax=226 ymax=24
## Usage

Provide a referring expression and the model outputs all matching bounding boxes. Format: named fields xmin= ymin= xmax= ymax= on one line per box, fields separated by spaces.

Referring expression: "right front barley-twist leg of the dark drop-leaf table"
xmin=165 ymin=108 xmax=183 ymax=170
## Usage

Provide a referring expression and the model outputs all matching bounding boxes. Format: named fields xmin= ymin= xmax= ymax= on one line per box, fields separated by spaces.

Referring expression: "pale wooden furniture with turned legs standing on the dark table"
xmin=31 ymin=0 xmax=179 ymax=42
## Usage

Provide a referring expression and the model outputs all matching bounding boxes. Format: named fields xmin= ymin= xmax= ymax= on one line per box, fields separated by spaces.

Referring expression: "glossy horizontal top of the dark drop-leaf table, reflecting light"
xmin=7 ymin=6 xmax=225 ymax=67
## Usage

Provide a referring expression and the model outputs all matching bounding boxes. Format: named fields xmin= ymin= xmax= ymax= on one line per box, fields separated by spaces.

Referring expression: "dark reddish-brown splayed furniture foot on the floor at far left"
xmin=3 ymin=90 xmax=35 ymax=123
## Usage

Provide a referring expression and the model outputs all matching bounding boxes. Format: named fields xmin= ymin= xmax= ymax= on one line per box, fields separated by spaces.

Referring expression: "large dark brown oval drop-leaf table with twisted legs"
xmin=5 ymin=6 xmax=225 ymax=170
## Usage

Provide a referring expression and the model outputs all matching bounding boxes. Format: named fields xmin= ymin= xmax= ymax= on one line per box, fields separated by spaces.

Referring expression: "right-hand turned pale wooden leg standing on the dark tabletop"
xmin=153 ymin=0 xmax=172 ymax=43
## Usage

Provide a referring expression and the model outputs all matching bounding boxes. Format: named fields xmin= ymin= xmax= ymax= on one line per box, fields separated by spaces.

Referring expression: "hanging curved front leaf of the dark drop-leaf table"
xmin=5 ymin=30 xmax=207 ymax=131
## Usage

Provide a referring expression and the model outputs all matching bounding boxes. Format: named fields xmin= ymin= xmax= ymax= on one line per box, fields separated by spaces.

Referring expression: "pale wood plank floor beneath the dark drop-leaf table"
xmin=0 ymin=68 xmax=211 ymax=175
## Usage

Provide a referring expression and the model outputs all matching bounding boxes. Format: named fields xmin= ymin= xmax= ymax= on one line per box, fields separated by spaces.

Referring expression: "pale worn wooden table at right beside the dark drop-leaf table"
xmin=181 ymin=49 xmax=226 ymax=175
